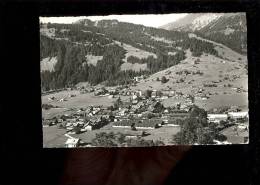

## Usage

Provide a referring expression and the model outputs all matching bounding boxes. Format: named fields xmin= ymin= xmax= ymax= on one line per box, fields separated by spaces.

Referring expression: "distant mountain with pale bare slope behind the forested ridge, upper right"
xmin=161 ymin=13 xmax=247 ymax=54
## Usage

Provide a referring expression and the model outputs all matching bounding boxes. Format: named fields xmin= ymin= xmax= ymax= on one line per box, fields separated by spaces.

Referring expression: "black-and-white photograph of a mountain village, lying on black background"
xmin=39 ymin=12 xmax=249 ymax=148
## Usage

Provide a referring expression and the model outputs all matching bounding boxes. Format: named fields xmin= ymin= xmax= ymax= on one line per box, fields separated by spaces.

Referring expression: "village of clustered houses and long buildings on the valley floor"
xmin=42 ymin=76 xmax=249 ymax=148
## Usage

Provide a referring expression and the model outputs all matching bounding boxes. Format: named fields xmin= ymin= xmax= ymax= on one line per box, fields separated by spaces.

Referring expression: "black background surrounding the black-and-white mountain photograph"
xmin=0 ymin=0 xmax=260 ymax=185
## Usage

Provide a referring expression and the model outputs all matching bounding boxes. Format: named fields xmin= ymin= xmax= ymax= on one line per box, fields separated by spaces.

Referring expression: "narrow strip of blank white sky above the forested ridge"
xmin=40 ymin=13 xmax=187 ymax=27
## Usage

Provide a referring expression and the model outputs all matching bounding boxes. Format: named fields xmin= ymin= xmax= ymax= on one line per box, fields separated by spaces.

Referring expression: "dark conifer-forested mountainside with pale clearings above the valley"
xmin=40 ymin=19 xmax=247 ymax=91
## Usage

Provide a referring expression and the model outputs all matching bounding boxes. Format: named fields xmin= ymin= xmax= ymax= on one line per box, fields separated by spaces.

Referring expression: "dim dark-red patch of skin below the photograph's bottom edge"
xmin=60 ymin=146 xmax=191 ymax=185
